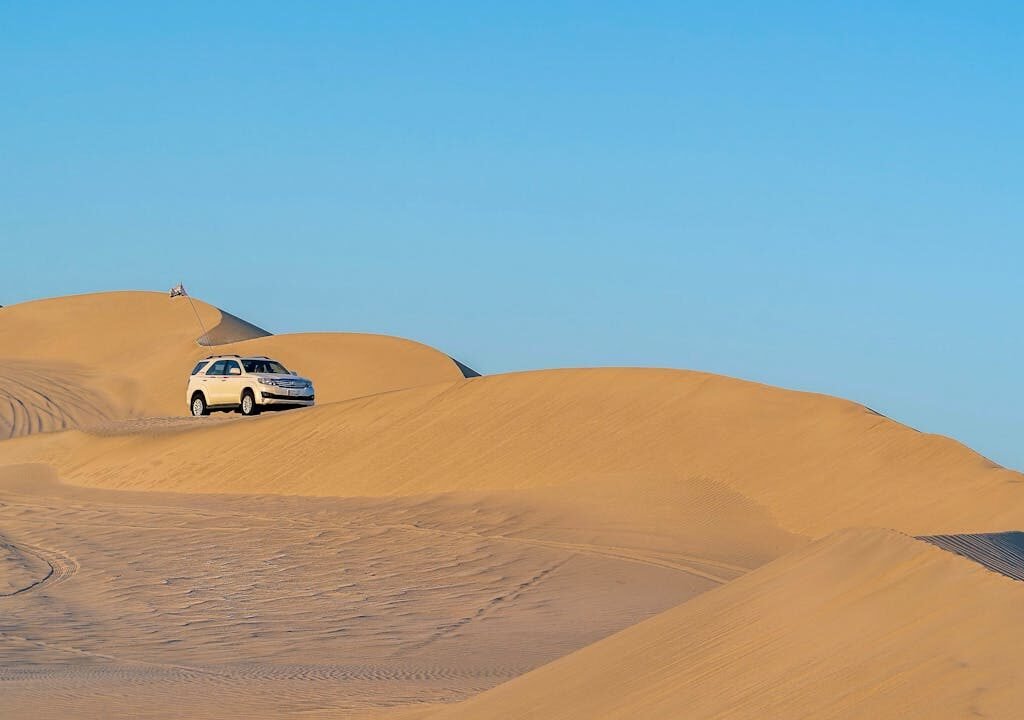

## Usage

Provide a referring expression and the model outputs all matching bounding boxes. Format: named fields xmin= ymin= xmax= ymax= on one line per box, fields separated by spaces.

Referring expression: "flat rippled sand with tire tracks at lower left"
xmin=0 ymin=467 xmax=714 ymax=718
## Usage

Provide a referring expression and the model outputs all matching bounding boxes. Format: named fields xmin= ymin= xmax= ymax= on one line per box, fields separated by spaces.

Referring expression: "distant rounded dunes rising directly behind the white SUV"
xmin=0 ymin=292 xmax=462 ymax=428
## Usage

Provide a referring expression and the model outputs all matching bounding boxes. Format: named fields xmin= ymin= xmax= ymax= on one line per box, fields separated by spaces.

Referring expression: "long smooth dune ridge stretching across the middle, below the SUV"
xmin=8 ymin=370 xmax=1024 ymax=537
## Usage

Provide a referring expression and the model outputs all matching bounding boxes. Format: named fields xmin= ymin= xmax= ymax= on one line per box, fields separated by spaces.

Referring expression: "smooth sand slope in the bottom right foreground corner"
xmin=427 ymin=530 xmax=1024 ymax=720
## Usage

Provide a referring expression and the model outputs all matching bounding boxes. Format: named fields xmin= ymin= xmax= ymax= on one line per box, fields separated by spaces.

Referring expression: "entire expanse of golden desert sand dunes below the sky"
xmin=0 ymin=293 xmax=1024 ymax=720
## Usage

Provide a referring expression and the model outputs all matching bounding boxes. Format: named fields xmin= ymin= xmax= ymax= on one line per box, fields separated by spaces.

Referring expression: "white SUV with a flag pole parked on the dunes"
xmin=187 ymin=355 xmax=314 ymax=416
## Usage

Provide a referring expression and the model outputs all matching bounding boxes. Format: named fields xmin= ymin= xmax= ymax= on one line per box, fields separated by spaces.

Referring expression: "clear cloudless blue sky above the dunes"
xmin=6 ymin=0 xmax=1024 ymax=468
